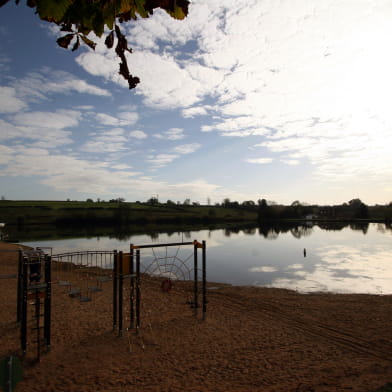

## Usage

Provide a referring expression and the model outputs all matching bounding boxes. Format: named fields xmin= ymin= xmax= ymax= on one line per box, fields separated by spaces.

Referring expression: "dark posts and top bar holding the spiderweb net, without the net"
xmin=113 ymin=240 xmax=207 ymax=336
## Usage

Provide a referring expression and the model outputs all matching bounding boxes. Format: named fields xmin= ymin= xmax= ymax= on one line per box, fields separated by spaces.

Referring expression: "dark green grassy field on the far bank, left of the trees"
xmin=0 ymin=200 xmax=257 ymax=226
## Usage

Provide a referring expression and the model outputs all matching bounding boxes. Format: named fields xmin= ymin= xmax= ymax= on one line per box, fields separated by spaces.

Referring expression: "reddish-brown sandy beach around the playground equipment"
xmin=0 ymin=243 xmax=392 ymax=392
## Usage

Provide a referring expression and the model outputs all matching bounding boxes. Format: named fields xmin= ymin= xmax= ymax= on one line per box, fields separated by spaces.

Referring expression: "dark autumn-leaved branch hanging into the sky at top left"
xmin=0 ymin=0 xmax=189 ymax=89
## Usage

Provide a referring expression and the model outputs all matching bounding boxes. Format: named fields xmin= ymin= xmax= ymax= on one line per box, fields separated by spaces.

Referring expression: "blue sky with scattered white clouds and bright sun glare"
xmin=0 ymin=0 xmax=392 ymax=205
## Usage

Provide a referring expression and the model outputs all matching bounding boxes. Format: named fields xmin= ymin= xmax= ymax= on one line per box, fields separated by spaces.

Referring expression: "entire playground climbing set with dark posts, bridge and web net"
xmin=0 ymin=240 xmax=207 ymax=360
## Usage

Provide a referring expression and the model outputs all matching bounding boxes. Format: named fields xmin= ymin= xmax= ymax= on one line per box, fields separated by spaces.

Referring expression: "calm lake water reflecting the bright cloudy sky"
xmin=22 ymin=223 xmax=392 ymax=294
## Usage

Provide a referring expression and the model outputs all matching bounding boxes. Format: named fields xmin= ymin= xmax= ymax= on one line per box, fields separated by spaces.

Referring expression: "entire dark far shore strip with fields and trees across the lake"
xmin=0 ymin=198 xmax=392 ymax=226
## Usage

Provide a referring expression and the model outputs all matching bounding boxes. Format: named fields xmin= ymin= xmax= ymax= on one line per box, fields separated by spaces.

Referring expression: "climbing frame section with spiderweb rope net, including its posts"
xmin=113 ymin=240 xmax=207 ymax=344
